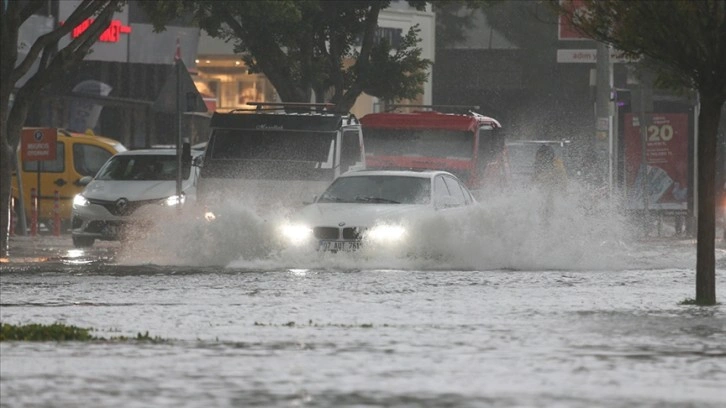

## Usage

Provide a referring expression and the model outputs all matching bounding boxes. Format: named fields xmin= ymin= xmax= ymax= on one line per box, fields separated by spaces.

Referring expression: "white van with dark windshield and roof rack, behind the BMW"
xmin=199 ymin=102 xmax=364 ymax=216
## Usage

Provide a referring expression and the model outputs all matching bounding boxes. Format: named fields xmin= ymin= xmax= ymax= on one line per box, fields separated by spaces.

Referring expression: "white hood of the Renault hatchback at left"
xmin=83 ymin=180 xmax=191 ymax=201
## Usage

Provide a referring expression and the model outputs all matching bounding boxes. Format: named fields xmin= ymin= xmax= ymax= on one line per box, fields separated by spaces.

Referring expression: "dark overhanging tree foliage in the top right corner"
xmin=549 ymin=0 xmax=726 ymax=100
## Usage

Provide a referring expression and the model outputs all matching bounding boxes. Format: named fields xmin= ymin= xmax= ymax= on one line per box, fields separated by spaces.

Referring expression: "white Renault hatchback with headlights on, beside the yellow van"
xmin=72 ymin=149 xmax=202 ymax=247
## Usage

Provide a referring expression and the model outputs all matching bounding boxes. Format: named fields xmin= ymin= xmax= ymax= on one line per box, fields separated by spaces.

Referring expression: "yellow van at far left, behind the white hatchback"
xmin=12 ymin=129 xmax=126 ymax=231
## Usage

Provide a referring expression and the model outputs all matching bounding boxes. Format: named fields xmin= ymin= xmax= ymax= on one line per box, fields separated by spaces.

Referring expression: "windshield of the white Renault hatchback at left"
xmin=96 ymin=155 xmax=191 ymax=180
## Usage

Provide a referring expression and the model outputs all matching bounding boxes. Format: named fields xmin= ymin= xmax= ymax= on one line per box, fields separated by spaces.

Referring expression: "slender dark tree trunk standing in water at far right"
xmin=696 ymin=92 xmax=723 ymax=306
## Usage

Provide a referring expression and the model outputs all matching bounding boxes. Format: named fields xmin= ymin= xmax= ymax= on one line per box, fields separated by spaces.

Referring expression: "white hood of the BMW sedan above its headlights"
xmin=291 ymin=203 xmax=433 ymax=226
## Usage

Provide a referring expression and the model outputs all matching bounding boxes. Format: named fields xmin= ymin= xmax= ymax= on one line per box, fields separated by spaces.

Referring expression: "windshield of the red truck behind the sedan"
xmin=364 ymin=128 xmax=474 ymax=159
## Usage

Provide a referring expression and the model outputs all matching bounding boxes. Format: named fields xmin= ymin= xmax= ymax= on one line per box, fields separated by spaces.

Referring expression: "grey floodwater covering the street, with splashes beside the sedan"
xmin=0 ymin=189 xmax=726 ymax=407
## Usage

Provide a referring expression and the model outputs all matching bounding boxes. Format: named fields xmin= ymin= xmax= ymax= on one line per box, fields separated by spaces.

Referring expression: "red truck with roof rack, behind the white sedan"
xmin=361 ymin=105 xmax=509 ymax=195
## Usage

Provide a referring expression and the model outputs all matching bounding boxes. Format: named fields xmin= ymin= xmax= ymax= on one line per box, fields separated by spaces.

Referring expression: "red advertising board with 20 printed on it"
xmin=624 ymin=113 xmax=690 ymax=210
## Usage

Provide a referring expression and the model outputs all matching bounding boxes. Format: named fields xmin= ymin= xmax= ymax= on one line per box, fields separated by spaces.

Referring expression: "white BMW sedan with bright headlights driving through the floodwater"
xmin=280 ymin=170 xmax=475 ymax=252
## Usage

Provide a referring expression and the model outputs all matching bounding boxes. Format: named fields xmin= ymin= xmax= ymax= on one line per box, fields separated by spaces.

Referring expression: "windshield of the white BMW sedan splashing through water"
xmin=318 ymin=176 xmax=431 ymax=204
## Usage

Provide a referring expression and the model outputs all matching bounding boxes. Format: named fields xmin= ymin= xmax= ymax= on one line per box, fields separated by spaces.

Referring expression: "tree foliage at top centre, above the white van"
xmin=139 ymin=0 xmax=450 ymax=111
